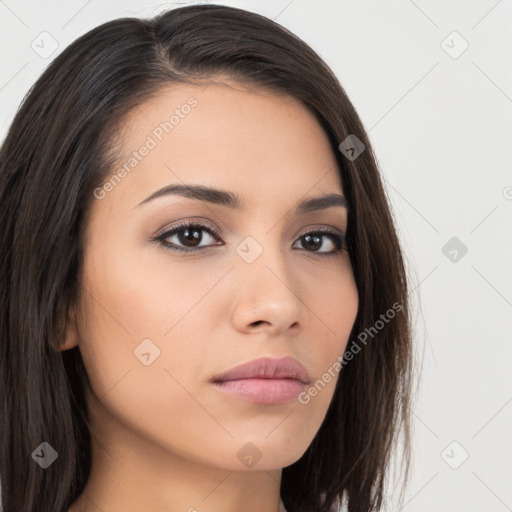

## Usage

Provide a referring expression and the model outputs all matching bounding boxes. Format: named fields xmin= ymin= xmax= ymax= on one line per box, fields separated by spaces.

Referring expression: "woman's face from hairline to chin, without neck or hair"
xmin=70 ymin=84 xmax=358 ymax=471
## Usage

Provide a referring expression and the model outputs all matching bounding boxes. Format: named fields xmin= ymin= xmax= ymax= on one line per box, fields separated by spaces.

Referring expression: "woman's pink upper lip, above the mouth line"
xmin=212 ymin=356 xmax=310 ymax=384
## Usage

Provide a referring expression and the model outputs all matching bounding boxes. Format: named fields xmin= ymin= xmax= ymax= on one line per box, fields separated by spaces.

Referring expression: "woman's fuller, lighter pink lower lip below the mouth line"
xmin=210 ymin=379 xmax=305 ymax=404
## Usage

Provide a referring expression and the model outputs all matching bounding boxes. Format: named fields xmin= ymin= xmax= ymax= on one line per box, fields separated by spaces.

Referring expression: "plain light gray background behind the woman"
xmin=0 ymin=0 xmax=512 ymax=512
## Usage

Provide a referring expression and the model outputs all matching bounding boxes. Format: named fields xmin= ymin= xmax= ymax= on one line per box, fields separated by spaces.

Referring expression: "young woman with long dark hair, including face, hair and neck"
xmin=0 ymin=5 xmax=411 ymax=512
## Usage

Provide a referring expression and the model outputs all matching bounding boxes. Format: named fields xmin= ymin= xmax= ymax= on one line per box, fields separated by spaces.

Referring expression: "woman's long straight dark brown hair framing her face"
xmin=0 ymin=5 xmax=412 ymax=512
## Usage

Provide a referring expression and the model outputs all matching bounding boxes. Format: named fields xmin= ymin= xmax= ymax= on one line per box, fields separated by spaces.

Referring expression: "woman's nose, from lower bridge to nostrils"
xmin=231 ymin=250 xmax=307 ymax=336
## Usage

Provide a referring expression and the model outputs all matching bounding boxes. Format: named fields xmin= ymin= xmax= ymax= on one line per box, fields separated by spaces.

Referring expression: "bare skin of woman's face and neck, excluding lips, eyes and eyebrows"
xmin=63 ymin=82 xmax=358 ymax=512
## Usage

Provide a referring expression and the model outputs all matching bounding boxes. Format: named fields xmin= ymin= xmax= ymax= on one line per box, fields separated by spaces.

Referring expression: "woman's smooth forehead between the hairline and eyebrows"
xmin=102 ymin=83 xmax=342 ymax=209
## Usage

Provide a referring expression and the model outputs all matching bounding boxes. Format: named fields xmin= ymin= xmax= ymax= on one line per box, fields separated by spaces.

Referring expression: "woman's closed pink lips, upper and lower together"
xmin=211 ymin=356 xmax=310 ymax=404
